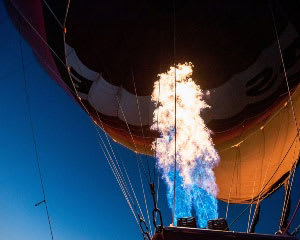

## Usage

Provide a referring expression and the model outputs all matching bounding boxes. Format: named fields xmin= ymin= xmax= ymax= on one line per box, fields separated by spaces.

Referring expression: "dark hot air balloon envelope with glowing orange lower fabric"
xmin=6 ymin=0 xmax=300 ymax=239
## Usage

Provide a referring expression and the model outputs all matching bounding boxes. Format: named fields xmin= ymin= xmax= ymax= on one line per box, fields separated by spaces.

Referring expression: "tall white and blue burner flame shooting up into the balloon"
xmin=151 ymin=63 xmax=219 ymax=227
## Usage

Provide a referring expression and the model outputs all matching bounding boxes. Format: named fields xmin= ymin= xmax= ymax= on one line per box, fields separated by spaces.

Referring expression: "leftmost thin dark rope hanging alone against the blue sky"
xmin=19 ymin=24 xmax=54 ymax=240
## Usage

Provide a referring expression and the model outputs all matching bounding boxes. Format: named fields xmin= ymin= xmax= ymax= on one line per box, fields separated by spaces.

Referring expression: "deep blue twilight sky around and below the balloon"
xmin=0 ymin=0 xmax=300 ymax=240
